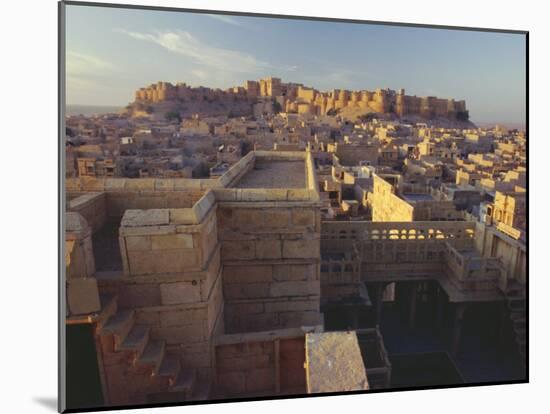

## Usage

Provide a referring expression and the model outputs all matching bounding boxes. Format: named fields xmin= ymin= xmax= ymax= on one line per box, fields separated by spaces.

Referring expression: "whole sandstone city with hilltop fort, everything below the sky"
xmin=64 ymin=77 xmax=527 ymax=407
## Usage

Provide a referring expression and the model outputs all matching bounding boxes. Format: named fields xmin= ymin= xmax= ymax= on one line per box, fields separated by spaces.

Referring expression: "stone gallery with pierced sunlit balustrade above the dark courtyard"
xmin=321 ymin=221 xmax=503 ymax=290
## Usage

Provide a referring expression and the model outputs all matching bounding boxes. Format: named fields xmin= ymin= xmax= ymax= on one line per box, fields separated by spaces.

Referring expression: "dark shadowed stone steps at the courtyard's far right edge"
xmin=505 ymin=283 xmax=527 ymax=366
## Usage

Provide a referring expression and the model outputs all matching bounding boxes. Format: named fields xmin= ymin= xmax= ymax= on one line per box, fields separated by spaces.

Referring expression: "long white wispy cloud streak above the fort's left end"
xmin=115 ymin=29 xmax=271 ymax=73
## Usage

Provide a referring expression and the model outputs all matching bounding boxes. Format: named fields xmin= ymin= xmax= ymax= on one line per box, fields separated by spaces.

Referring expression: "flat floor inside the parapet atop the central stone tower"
xmin=235 ymin=159 xmax=307 ymax=188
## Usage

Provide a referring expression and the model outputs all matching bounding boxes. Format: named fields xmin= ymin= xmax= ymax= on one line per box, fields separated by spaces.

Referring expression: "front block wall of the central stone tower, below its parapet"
xmin=218 ymin=203 xmax=321 ymax=333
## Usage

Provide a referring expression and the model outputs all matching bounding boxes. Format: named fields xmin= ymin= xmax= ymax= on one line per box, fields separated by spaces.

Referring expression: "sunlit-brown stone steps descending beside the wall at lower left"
xmin=97 ymin=295 xmax=210 ymax=405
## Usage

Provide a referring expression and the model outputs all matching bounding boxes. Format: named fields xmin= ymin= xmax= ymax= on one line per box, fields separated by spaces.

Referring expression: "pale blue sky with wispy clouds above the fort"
xmin=66 ymin=5 xmax=526 ymax=124
